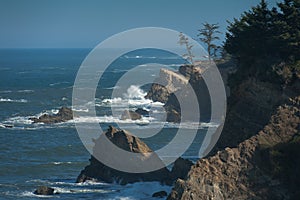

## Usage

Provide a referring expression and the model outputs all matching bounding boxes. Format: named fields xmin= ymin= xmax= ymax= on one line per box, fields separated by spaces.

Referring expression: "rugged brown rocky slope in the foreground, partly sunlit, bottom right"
xmin=168 ymin=96 xmax=300 ymax=200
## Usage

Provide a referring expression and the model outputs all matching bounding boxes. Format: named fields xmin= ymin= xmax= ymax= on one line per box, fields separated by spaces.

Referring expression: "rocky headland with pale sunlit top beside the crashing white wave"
xmin=146 ymin=65 xmax=211 ymax=123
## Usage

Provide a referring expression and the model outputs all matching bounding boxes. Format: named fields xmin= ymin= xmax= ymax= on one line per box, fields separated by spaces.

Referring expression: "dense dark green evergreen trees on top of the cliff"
xmin=224 ymin=0 xmax=300 ymax=85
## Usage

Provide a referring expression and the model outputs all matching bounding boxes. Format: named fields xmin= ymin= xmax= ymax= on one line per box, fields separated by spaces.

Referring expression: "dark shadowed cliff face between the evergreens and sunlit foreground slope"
xmin=212 ymin=79 xmax=288 ymax=153
